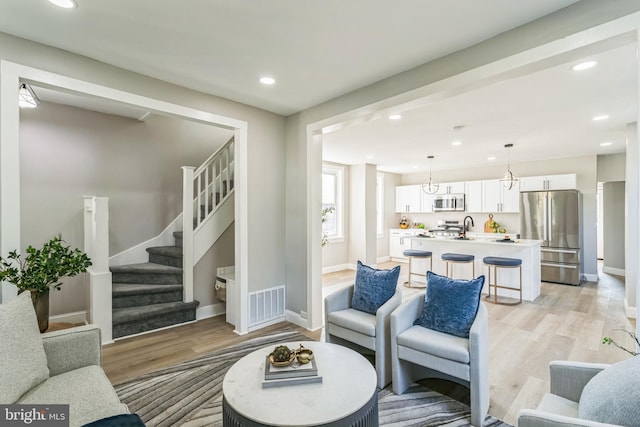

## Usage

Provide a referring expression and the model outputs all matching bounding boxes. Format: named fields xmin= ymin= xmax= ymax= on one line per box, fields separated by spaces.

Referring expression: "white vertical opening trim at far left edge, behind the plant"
xmin=0 ymin=62 xmax=21 ymax=302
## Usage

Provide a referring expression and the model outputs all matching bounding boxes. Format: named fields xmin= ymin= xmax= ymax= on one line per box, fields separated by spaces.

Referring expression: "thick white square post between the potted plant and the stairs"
xmin=84 ymin=196 xmax=113 ymax=344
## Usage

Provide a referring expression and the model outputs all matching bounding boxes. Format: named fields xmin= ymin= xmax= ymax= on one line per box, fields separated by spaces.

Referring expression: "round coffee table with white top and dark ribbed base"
xmin=222 ymin=341 xmax=378 ymax=427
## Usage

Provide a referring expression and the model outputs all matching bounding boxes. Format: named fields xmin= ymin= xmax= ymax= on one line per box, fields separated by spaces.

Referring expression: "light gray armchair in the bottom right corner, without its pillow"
xmin=517 ymin=361 xmax=614 ymax=427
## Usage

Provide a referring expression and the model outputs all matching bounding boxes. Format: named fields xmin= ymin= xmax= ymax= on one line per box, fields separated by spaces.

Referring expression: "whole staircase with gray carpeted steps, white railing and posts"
xmin=99 ymin=138 xmax=235 ymax=340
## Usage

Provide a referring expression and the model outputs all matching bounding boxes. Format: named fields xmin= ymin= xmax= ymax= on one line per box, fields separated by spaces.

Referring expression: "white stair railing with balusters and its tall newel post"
xmin=182 ymin=138 xmax=235 ymax=302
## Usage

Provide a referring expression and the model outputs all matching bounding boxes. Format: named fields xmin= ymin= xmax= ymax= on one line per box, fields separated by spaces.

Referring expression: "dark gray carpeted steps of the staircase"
xmin=110 ymin=232 xmax=199 ymax=338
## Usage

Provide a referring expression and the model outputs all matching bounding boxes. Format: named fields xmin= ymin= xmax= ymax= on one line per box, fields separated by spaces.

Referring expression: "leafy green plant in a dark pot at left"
xmin=0 ymin=235 xmax=91 ymax=332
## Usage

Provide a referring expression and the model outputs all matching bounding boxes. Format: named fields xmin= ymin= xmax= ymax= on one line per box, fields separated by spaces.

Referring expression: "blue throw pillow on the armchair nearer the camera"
xmin=413 ymin=271 xmax=484 ymax=338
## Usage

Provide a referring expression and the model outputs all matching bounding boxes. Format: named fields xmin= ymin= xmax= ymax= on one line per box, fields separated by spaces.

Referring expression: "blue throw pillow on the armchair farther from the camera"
xmin=351 ymin=261 xmax=400 ymax=314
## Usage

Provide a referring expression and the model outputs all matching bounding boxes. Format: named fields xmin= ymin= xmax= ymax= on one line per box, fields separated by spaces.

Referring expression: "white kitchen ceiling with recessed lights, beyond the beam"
xmin=323 ymin=44 xmax=638 ymax=174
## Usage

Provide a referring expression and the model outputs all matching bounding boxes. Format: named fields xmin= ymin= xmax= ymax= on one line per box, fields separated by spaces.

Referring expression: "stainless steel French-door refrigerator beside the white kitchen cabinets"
xmin=520 ymin=190 xmax=583 ymax=285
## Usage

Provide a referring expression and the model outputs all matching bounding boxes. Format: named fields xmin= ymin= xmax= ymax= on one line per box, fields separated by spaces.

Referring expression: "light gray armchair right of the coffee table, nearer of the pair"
xmin=391 ymin=293 xmax=489 ymax=427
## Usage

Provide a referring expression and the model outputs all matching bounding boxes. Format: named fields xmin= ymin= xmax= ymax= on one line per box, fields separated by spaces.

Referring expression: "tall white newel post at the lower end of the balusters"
xmin=182 ymin=166 xmax=196 ymax=302
